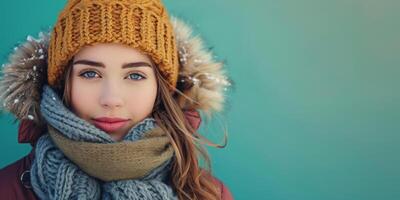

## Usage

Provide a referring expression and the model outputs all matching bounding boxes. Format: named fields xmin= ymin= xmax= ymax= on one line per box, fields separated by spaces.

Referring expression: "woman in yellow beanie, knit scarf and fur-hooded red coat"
xmin=0 ymin=0 xmax=232 ymax=199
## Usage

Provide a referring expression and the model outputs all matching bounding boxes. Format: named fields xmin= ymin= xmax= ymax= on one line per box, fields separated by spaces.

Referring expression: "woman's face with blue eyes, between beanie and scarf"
xmin=70 ymin=43 xmax=157 ymax=141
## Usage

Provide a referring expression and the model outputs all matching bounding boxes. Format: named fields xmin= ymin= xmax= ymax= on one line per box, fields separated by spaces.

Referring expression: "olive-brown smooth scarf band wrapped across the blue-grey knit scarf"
xmin=49 ymin=126 xmax=173 ymax=181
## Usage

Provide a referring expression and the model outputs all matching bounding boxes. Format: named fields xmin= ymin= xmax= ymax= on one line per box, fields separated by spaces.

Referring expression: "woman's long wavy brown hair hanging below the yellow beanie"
xmin=60 ymin=58 xmax=227 ymax=200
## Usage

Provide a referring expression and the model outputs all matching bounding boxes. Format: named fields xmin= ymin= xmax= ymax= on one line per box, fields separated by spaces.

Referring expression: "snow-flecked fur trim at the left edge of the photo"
xmin=0 ymin=33 xmax=49 ymax=123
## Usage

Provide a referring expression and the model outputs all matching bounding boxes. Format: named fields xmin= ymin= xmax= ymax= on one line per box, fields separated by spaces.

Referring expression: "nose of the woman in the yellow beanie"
xmin=100 ymin=81 xmax=124 ymax=109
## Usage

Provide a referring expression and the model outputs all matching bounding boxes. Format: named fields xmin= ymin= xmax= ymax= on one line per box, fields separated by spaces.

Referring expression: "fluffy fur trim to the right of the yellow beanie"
xmin=171 ymin=17 xmax=231 ymax=116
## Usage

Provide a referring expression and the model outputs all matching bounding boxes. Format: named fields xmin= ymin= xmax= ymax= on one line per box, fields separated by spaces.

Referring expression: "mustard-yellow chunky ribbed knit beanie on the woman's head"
xmin=47 ymin=0 xmax=179 ymax=88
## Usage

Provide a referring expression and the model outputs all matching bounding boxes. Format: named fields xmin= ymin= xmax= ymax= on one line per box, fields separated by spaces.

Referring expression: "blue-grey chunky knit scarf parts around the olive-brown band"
xmin=31 ymin=85 xmax=178 ymax=200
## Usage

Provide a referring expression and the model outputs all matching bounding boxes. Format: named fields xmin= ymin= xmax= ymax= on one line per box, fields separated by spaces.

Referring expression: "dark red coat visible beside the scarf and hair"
xmin=0 ymin=113 xmax=233 ymax=200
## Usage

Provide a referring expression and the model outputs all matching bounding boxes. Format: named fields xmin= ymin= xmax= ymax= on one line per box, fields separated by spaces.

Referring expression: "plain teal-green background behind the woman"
xmin=0 ymin=0 xmax=400 ymax=200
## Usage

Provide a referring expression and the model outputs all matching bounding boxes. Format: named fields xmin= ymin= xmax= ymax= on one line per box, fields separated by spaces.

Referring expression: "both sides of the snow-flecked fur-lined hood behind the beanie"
xmin=0 ymin=17 xmax=230 ymax=131
